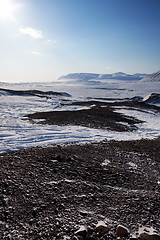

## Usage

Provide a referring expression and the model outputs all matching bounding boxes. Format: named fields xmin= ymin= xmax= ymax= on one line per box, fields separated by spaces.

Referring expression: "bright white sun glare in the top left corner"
xmin=0 ymin=0 xmax=17 ymax=19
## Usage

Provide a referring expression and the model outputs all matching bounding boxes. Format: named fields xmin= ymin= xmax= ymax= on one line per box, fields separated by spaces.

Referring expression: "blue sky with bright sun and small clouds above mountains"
xmin=0 ymin=0 xmax=160 ymax=82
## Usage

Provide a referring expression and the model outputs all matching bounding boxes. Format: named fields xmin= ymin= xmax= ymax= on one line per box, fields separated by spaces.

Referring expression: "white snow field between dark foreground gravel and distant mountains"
xmin=0 ymin=81 xmax=160 ymax=152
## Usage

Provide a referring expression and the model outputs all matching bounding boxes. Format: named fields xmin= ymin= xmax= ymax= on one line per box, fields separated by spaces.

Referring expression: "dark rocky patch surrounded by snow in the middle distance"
xmin=25 ymin=100 xmax=160 ymax=132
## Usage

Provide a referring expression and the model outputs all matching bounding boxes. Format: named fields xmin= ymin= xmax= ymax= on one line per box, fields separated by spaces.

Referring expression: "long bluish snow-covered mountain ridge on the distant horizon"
xmin=58 ymin=72 xmax=147 ymax=81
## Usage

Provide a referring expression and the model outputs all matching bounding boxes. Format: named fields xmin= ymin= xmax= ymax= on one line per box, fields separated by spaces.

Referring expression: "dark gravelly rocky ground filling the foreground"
xmin=0 ymin=138 xmax=160 ymax=240
